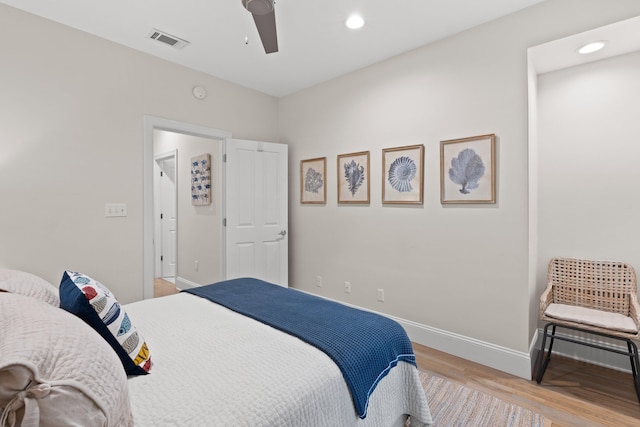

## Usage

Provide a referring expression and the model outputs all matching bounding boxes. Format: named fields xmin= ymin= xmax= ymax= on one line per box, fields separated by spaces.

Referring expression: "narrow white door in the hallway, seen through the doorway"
xmin=158 ymin=156 xmax=178 ymax=278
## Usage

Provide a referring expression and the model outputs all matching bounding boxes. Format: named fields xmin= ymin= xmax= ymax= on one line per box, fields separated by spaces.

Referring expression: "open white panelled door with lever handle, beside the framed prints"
xmin=225 ymin=139 xmax=289 ymax=286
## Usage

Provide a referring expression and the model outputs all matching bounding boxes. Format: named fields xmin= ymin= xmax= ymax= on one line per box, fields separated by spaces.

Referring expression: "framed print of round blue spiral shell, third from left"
xmin=382 ymin=145 xmax=424 ymax=204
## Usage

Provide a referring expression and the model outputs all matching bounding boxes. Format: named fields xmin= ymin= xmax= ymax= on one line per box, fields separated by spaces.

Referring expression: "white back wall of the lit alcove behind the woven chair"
xmin=538 ymin=52 xmax=640 ymax=280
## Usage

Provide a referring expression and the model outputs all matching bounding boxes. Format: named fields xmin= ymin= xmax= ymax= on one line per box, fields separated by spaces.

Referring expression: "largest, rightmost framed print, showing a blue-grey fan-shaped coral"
xmin=440 ymin=134 xmax=496 ymax=204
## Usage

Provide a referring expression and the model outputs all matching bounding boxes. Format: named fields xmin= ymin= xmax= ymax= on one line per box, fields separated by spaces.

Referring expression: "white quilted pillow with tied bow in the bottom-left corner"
xmin=0 ymin=293 xmax=133 ymax=427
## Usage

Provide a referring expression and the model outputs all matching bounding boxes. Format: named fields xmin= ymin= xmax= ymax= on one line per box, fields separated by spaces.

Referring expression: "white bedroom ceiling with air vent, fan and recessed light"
xmin=0 ymin=0 xmax=542 ymax=97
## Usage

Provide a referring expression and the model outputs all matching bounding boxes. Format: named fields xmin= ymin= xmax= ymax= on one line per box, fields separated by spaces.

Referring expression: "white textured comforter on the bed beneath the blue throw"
xmin=125 ymin=293 xmax=431 ymax=427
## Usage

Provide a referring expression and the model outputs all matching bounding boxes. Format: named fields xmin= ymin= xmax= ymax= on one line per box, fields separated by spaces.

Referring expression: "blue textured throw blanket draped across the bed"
xmin=183 ymin=278 xmax=416 ymax=418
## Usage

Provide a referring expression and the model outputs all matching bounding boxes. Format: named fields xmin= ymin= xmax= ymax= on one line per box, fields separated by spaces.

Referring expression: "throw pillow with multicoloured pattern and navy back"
xmin=60 ymin=271 xmax=151 ymax=375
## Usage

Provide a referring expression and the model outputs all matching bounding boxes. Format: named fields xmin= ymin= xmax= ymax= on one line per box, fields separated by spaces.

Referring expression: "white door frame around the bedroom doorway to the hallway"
xmin=142 ymin=115 xmax=231 ymax=299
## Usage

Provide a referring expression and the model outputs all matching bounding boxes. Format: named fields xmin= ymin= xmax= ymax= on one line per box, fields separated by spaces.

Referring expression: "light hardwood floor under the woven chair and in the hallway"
xmin=154 ymin=279 xmax=640 ymax=427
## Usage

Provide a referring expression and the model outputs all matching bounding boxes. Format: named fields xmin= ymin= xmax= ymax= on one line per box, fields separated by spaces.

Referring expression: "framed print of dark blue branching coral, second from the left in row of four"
xmin=338 ymin=151 xmax=369 ymax=204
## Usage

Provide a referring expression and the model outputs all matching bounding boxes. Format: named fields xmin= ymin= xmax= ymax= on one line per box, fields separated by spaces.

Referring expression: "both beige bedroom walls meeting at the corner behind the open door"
xmin=0 ymin=0 xmax=640 ymax=374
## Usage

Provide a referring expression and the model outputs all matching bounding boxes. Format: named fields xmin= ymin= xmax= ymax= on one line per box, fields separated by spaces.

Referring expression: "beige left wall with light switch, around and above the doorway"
xmin=0 ymin=4 xmax=278 ymax=303
